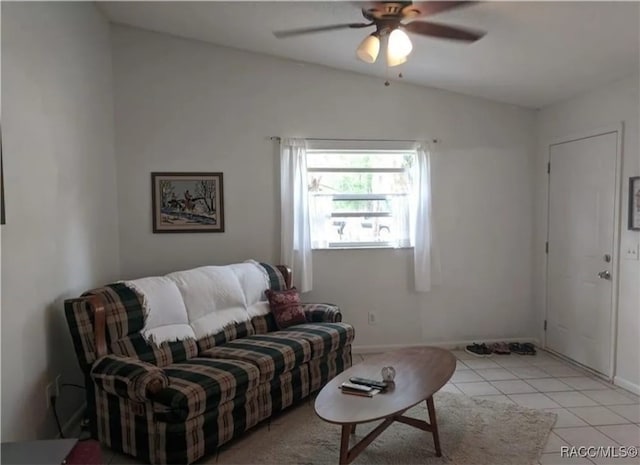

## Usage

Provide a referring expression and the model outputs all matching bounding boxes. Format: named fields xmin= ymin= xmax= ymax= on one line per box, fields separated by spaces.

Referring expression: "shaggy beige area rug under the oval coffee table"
xmin=212 ymin=392 xmax=556 ymax=465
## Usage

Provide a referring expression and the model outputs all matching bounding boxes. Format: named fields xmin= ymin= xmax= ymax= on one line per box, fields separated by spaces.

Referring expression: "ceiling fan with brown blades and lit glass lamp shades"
xmin=273 ymin=1 xmax=485 ymax=66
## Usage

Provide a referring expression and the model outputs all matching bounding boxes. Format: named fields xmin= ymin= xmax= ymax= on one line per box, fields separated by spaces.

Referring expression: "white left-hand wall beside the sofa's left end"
xmin=2 ymin=2 xmax=119 ymax=441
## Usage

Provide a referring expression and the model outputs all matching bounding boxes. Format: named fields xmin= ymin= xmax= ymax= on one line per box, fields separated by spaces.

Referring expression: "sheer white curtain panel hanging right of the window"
xmin=411 ymin=142 xmax=439 ymax=292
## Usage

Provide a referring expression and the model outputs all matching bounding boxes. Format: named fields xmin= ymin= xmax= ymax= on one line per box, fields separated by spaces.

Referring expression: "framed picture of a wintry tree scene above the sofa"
xmin=151 ymin=173 xmax=224 ymax=233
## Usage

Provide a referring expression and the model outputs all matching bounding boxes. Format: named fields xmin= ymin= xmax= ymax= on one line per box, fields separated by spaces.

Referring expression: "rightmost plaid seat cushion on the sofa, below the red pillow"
xmin=264 ymin=323 xmax=355 ymax=359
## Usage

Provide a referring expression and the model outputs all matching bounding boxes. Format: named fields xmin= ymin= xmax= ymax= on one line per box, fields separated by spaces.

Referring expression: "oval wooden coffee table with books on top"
xmin=315 ymin=347 xmax=456 ymax=465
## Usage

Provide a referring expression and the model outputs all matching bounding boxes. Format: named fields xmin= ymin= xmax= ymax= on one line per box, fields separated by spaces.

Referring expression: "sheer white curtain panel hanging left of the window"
xmin=280 ymin=139 xmax=312 ymax=292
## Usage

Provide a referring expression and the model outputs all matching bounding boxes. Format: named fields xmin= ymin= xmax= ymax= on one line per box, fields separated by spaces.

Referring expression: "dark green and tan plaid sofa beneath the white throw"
xmin=65 ymin=264 xmax=354 ymax=464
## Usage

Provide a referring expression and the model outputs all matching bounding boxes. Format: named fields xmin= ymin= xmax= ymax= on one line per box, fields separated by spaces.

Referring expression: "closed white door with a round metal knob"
xmin=546 ymin=132 xmax=618 ymax=375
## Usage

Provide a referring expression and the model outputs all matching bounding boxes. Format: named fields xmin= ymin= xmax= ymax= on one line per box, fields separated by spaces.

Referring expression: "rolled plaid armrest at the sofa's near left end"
xmin=91 ymin=355 xmax=169 ymax=402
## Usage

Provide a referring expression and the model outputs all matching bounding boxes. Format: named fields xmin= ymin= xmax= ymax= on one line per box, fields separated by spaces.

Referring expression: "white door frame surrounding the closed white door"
xmin=543 ymin=121 xmax=624 ymax=382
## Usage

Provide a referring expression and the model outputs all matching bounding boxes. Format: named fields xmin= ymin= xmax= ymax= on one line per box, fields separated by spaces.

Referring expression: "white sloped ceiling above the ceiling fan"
xmin=99 ymin=1 xmax=640 ymax=108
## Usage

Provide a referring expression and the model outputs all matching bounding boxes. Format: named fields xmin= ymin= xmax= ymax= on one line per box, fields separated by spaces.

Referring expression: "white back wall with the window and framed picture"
xmin=112 ymin=27 xmax=536 ymax=346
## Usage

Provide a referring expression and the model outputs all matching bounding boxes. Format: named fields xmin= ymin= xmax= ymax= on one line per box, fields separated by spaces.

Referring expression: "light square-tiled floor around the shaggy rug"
xmin=103 ymin=351 xmax=640 ymax=465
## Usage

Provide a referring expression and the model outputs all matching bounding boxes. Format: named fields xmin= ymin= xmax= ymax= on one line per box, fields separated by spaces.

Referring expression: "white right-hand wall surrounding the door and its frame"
xmin=534 ymin=75 xmax=640 ymax=393
